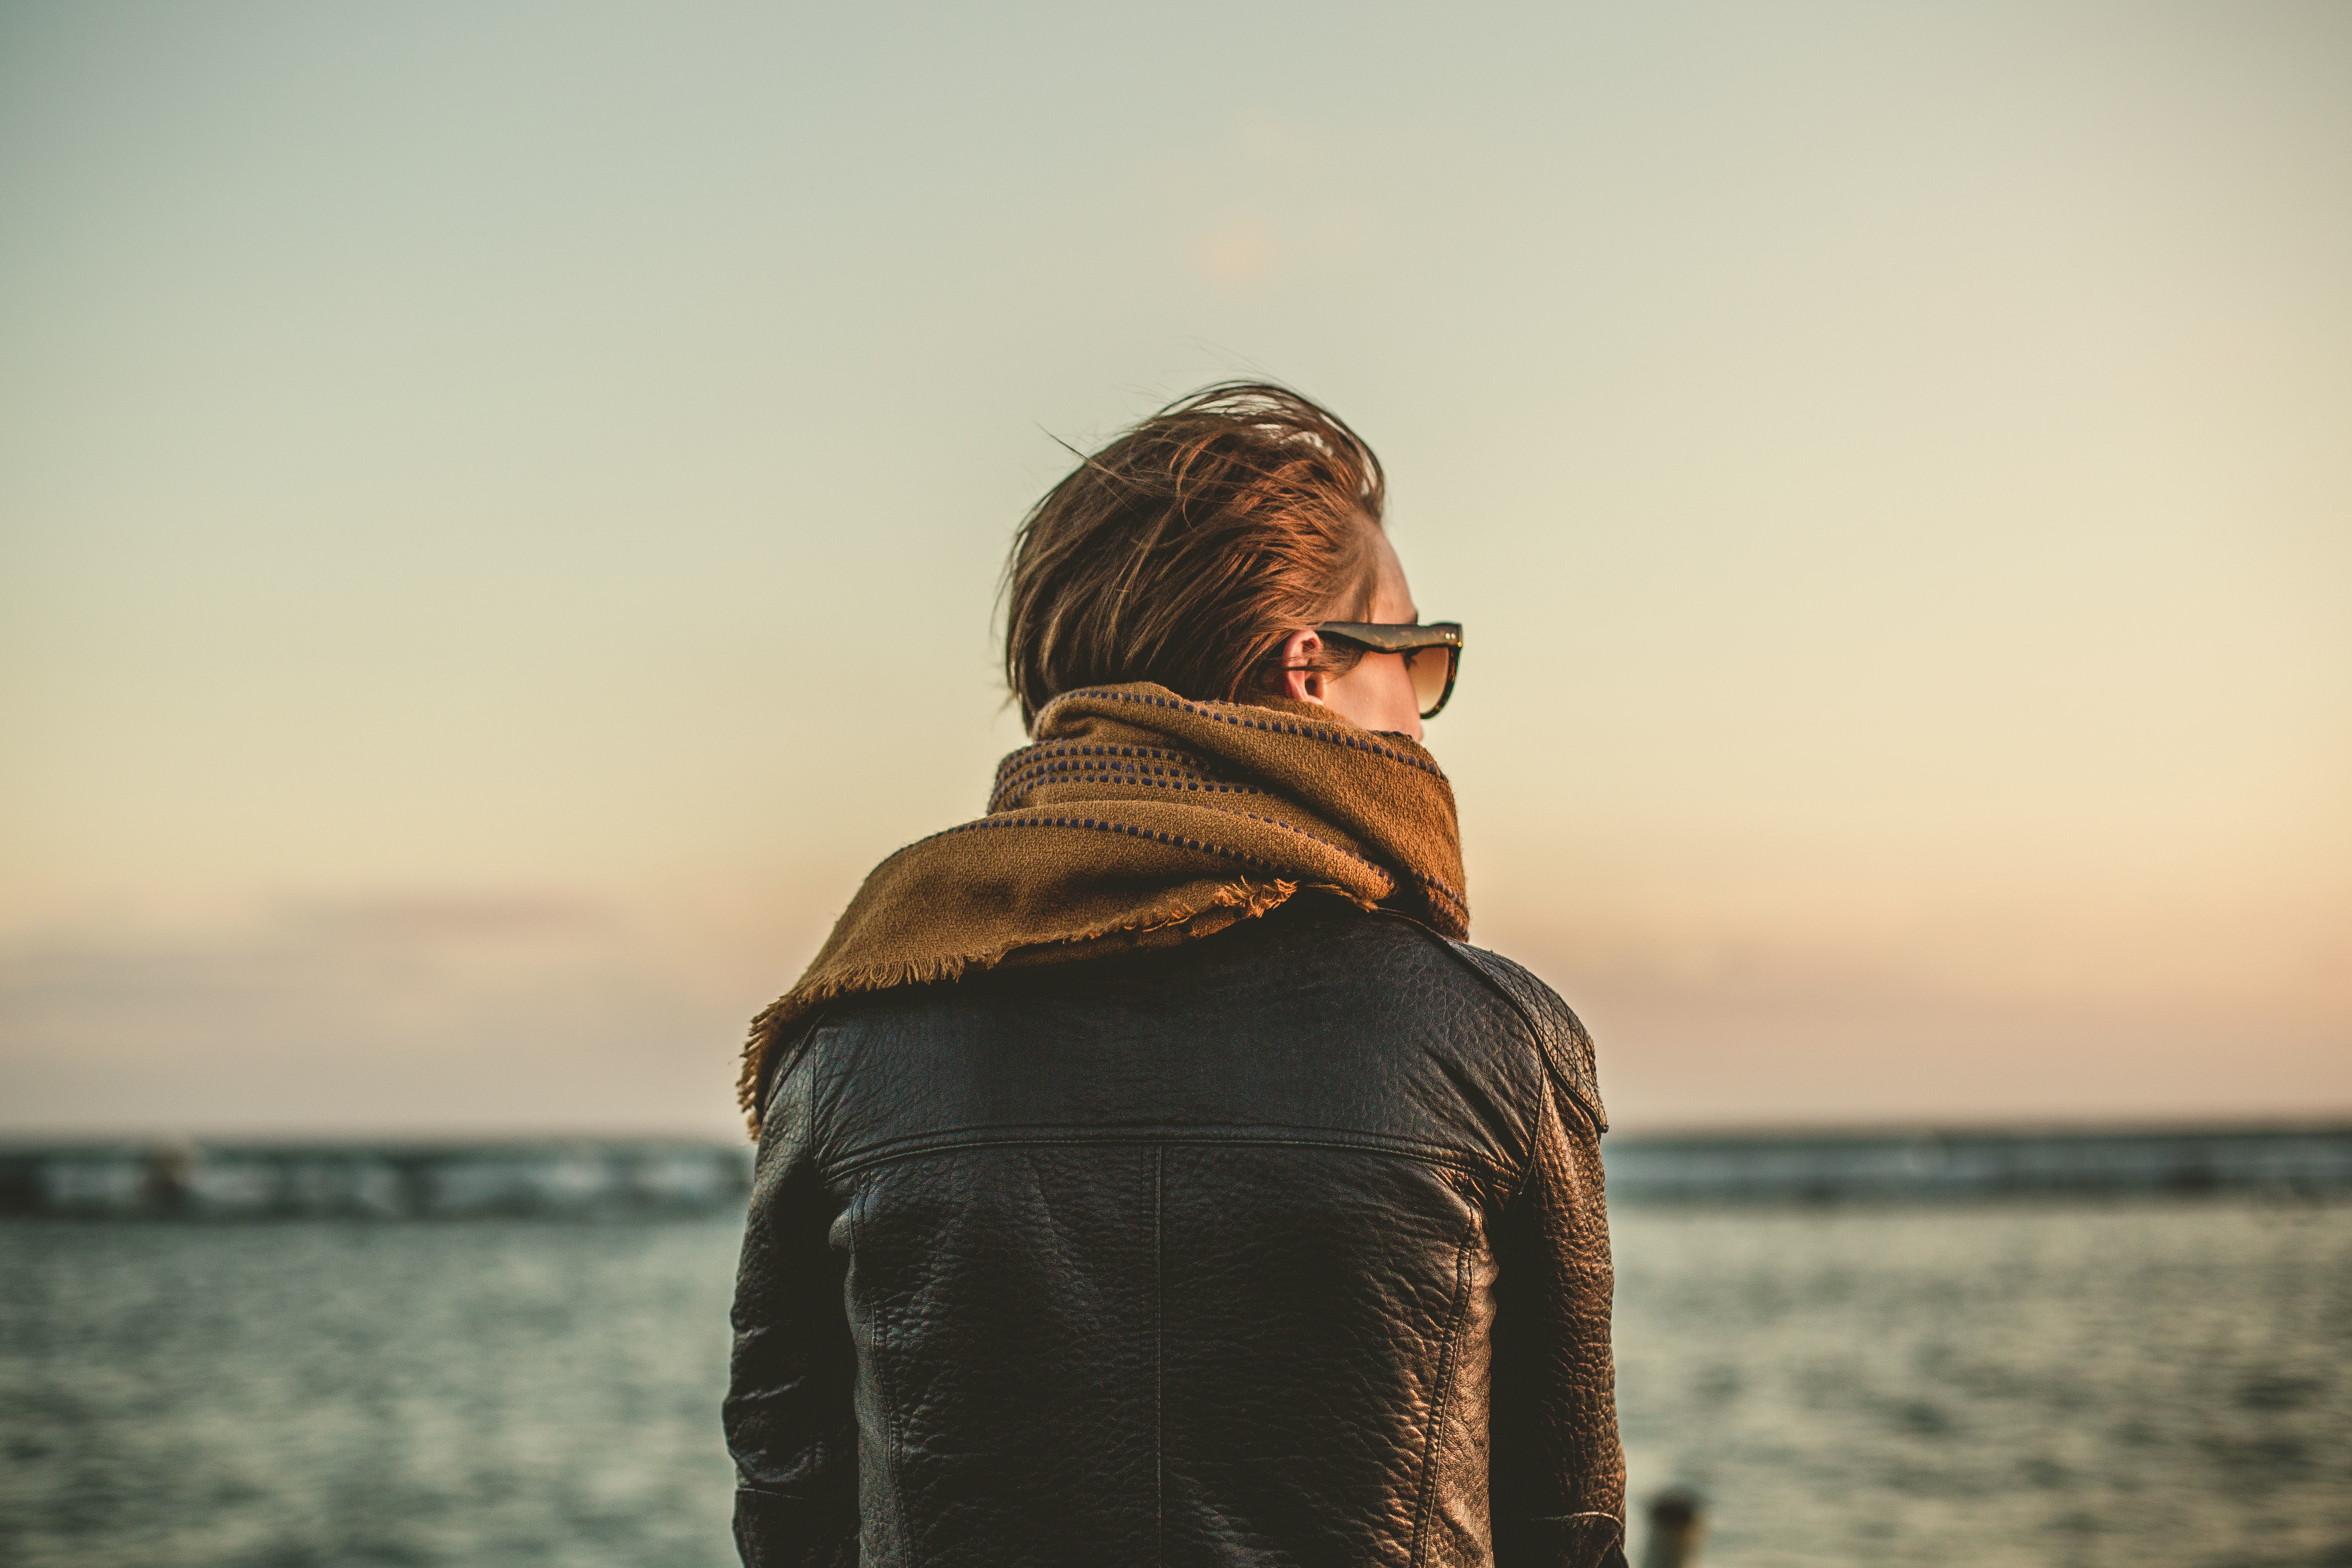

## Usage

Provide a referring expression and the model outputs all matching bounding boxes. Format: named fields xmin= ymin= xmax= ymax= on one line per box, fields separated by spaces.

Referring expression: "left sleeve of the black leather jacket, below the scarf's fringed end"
xmin=727 ymin=1056 xmax=858 ymax=1568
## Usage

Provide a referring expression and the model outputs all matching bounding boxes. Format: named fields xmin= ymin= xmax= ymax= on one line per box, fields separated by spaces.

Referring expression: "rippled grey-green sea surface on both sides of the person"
xmin=0 ymin=1201 xmax=2352 ymax=1568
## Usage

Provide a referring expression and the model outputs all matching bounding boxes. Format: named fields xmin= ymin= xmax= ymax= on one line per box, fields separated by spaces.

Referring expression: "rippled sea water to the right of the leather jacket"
xmin=1611 ymin=1201 xmax=2352 ymax=1568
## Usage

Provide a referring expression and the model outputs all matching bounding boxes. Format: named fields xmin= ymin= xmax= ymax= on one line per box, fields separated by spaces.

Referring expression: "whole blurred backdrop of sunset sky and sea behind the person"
xmin=0 ymin=0 xmax=2352 ymax=1566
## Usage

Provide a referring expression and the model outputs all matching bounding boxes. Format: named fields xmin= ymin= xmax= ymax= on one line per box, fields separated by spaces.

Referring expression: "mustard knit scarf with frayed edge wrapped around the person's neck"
xmin=736 ymin=684 xmax=1470 ymax=1138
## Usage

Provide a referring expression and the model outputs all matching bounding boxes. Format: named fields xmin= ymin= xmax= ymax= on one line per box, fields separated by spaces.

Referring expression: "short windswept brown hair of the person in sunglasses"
xmin=1004 ymin=381 xmax=1388 ymax=724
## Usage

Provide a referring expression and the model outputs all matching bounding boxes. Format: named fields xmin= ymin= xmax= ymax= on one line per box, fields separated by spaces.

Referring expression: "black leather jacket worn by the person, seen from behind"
xmin=727 ymin=895 xmax=1625 ymax=1568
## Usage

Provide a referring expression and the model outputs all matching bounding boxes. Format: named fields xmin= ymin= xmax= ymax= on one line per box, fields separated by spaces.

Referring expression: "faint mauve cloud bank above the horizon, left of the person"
xmin=0 ymin=891 xmax=743 ymax=1136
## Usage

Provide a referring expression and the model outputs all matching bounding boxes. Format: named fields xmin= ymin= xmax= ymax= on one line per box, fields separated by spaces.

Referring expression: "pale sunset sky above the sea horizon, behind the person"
xmin=0 ymin=0 xmax=2352 ymax=1138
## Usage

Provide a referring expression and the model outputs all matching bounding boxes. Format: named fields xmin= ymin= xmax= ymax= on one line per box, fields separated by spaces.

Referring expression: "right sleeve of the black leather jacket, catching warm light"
xmin=1477 ymin=952 xmax=1625 ymax=1568
